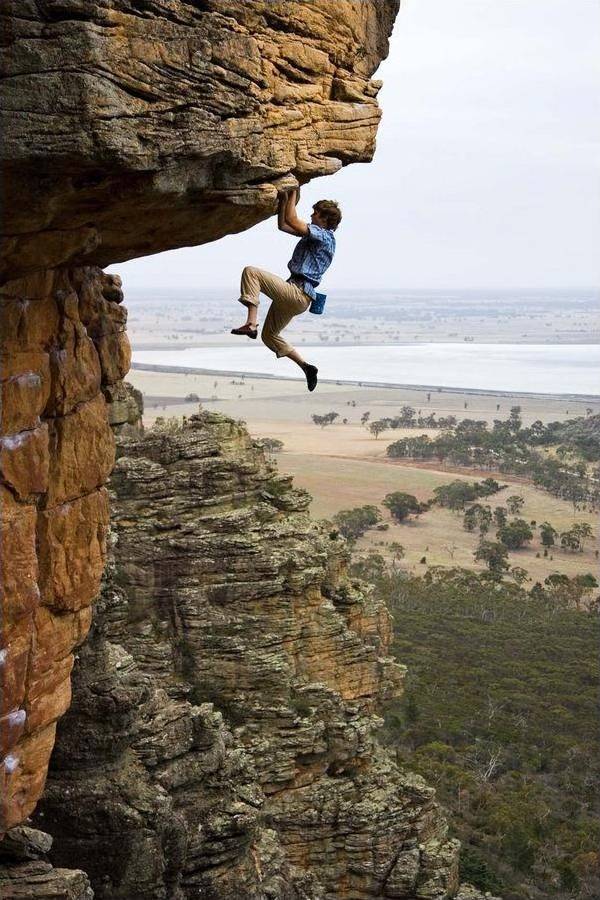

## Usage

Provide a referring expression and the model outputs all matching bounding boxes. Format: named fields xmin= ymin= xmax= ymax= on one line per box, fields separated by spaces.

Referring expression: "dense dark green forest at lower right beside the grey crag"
xmin=354 ymin=555 xmax=600 ymax=900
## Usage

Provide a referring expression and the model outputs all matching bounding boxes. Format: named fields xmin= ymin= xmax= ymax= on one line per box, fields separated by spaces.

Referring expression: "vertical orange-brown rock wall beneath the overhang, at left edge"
xmin=0 ymin=269 xmax=129 ymax=831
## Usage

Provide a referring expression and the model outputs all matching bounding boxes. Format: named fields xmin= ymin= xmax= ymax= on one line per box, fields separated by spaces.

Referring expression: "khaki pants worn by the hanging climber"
xmin=240 ymin=266 xmax=311 ymax=356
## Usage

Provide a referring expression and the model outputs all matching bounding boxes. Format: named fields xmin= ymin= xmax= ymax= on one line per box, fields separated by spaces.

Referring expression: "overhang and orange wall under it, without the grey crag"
xmin=0 ymin=0 xmax=398 ymax=852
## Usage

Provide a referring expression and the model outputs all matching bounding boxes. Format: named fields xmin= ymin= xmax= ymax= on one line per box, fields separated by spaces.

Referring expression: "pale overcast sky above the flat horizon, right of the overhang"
xmin=110 ymin=0 xmax=600 ymax=294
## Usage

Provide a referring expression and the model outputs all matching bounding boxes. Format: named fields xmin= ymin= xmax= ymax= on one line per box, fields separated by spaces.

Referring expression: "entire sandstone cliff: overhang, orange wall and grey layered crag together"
xmin=0 ymin=0 xmax=496 ymax=900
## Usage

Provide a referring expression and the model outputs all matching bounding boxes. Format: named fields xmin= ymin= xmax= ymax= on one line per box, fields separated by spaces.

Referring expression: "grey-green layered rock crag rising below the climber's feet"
xmin=38 ymin=413 xmax=457 ymax=900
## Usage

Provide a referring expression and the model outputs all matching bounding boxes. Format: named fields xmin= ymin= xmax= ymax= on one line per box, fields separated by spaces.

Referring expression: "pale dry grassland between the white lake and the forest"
xmin=130 ymin=370 xmax=597 ymax=581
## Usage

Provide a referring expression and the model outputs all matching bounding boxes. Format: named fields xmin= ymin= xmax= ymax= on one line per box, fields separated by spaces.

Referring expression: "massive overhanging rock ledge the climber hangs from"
xmin=0 ymin=0 xmax=399 ymax=278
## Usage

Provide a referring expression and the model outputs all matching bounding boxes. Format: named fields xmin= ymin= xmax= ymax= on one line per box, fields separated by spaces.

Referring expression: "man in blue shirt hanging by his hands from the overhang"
xmin=231 ymin=188 xmax=342 ymax=391
